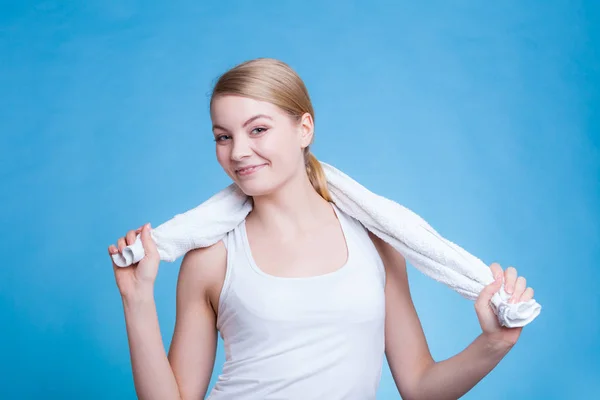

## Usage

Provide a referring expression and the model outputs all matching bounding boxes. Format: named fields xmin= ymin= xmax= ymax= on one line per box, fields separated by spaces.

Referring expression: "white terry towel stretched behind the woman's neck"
xmin=113 ymin=162 xmax=541 ymax=327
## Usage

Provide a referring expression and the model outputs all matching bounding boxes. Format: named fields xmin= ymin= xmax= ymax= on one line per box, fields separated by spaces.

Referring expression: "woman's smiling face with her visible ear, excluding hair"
xmin=211 ymin=95 xmax=313 ymax=196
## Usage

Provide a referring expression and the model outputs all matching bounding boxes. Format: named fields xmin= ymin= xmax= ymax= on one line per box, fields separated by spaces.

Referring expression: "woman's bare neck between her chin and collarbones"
xmin=246 ymin=170 xmax=333 ymax=239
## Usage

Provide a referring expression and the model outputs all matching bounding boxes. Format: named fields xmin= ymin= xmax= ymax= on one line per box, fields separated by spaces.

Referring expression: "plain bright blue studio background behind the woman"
xmin=0 ymin=0 xmax=600 ymax=399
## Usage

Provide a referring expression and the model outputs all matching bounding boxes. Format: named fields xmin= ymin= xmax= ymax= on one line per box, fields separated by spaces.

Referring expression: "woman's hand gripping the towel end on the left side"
xmin=108 ymin=223 xmax=160 ymax=298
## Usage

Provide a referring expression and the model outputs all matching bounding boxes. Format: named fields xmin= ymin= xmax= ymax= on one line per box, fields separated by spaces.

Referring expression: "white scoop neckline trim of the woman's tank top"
xmin=241 ymin=202 xmax=353 ymax=282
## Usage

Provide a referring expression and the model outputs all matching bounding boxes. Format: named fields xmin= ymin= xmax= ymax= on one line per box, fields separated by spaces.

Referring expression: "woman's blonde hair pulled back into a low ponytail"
xmin=210 ymin=58 xmax=332 ymax=201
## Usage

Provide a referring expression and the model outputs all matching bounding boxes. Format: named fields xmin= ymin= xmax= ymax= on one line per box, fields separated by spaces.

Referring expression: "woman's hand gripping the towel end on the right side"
xmin=475 ymin=263 xmax=533 ymax=348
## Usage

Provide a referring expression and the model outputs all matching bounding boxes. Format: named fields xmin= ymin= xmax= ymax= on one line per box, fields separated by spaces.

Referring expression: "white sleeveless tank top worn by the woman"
xmin=208 ymin=203 xmax=385 ymax=400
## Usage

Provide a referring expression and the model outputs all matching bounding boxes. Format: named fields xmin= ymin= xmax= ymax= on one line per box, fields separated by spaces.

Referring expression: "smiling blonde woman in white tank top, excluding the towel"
xmin=108 ymin=59 xmax=533 ymax=400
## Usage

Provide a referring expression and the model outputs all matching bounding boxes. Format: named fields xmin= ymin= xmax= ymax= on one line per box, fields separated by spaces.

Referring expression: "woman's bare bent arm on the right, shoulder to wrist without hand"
xmin=371 ymin=234 xmax=509 ymax=400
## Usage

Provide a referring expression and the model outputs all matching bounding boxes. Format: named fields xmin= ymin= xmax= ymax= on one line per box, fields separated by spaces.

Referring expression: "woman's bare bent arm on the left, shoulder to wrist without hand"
xmin=123 ymin=242 xmax=226 ymax=400
